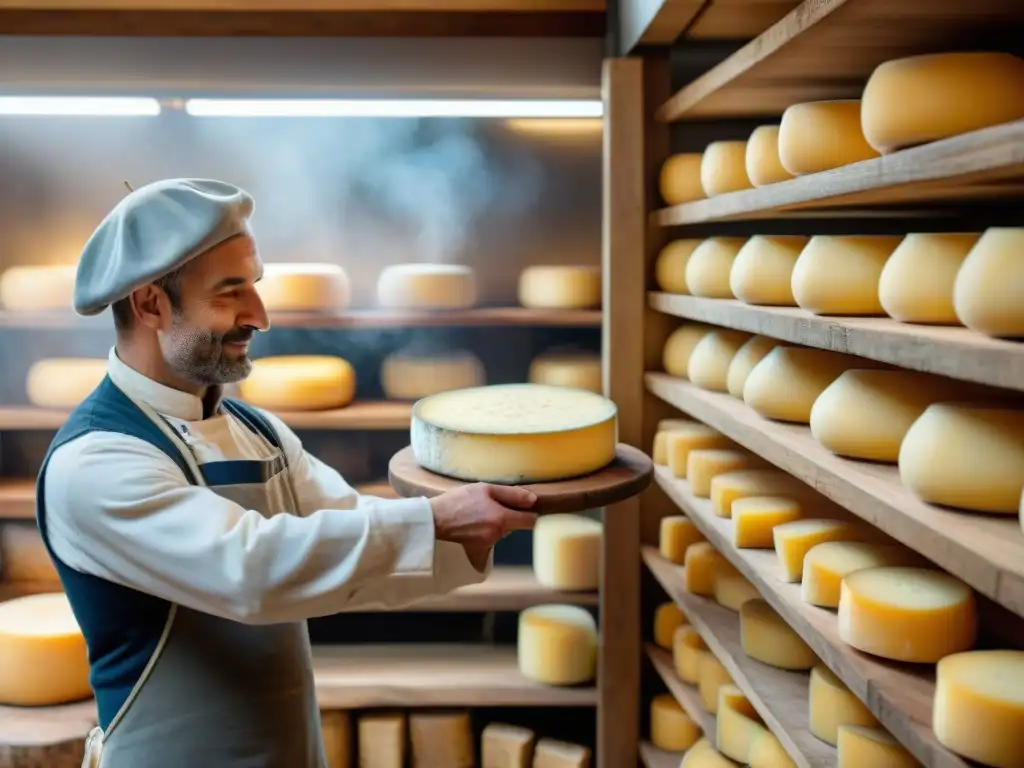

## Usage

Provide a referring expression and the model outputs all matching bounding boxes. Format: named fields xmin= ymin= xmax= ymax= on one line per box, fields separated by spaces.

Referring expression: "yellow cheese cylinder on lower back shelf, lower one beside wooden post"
xmin=516 ymin=604 xmax=597 ymax=685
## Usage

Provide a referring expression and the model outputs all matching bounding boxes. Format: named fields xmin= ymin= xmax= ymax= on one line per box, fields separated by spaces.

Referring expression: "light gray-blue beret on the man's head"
xmin=75 ymin=178 xmax=253 ymax=314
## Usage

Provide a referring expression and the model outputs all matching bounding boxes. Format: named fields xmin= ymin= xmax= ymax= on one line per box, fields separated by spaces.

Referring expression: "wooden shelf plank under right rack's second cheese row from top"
xmin=648 ymin=292 xmax=1024 ymax=390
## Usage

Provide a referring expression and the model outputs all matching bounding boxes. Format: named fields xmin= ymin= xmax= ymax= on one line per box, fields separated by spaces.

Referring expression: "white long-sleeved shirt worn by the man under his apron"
xmin=45 ymin=349 xmax=490 ymax=624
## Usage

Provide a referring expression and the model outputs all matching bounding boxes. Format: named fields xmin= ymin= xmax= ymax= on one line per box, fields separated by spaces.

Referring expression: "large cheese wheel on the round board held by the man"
xmin=411 ymin=384 xmax=616 ymax=484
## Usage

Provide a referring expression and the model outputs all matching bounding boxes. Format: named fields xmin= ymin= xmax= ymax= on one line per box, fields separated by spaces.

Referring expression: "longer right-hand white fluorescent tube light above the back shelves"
xmin=185 ymin=98 xmax=604 ymax=118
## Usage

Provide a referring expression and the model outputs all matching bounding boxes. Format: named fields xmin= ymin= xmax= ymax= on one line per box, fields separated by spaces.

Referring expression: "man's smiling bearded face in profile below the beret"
xmin=160 ymin=236 xmax=269 ymax=386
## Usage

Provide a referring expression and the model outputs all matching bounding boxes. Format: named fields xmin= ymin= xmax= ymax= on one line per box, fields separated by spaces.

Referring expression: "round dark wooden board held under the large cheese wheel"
xmin=387 ymin=443 xmax=654 ymax=514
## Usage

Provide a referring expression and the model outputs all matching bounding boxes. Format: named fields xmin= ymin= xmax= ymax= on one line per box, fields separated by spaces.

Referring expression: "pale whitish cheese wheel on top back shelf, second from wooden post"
xmin=377 ymin=264 xmax=476 ymax=309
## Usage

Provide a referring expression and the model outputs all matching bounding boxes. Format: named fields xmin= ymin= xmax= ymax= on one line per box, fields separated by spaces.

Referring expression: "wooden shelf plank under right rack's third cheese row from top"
xmin=646 ymin=373 xmax=1024 ymax=615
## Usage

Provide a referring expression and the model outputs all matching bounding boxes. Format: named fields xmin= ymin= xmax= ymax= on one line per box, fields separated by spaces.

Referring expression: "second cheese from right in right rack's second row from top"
xmin=879 ymin=232 xmax=981 ymax=326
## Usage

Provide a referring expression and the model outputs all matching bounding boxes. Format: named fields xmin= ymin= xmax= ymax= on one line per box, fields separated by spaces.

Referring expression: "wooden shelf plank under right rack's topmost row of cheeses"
xmin=651 ymin=118 xmax=1024 ymax=226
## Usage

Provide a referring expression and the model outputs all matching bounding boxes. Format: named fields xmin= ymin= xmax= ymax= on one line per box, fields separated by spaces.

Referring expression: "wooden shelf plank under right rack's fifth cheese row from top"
xmin=642 ymin=547 xmax=837 ymax=768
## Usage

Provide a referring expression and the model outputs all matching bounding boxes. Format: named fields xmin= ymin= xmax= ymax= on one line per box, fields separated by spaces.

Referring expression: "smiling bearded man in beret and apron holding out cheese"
xmin=37 ymin=179 xmax=536 ymax=768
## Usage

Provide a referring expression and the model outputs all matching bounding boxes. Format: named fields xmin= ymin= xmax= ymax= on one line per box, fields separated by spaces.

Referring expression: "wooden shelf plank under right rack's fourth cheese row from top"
xmin=644 ymin=468 xmax=969 ymax=768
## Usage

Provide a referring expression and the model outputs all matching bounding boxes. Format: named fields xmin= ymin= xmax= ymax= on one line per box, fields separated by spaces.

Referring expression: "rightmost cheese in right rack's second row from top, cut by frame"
xmin=953 ymin=227 xmax=1024 ymax=338
